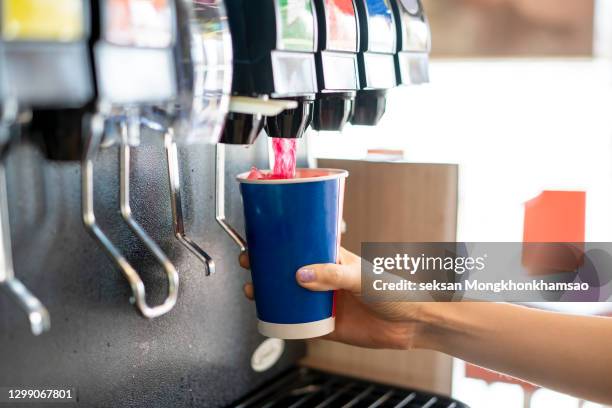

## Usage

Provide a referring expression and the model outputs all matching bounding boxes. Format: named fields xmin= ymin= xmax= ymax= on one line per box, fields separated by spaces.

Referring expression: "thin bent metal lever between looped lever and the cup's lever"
xmin=164 ymin=129 xmax=215 ymax=276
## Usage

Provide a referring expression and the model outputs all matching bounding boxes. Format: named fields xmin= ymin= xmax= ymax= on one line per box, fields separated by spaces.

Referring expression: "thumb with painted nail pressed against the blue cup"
xmin=296 ymin=264 xmax=361 ymax=295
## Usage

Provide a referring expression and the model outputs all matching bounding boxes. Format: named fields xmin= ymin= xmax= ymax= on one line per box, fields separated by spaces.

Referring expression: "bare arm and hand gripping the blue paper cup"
xmin=241 ymin=250 xmax=612 ymax=404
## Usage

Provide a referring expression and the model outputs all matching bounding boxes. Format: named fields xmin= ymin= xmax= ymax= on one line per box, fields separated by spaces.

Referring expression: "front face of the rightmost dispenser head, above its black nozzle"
xmin=391 ymin=0 xmax=431 ymax=85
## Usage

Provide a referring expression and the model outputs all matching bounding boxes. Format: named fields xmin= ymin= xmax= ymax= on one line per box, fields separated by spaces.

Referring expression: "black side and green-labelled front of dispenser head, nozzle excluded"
xmin=226 ymin=0 xmax=317 ymax=97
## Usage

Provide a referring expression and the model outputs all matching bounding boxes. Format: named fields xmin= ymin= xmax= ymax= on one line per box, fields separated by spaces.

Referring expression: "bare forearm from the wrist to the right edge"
xmin=417 ymin=303 xmax=612 ymax=404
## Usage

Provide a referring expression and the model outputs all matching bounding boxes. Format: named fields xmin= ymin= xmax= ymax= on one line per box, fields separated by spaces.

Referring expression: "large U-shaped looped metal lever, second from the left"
xmin=81 ymin=114 xmax=179 ymax=319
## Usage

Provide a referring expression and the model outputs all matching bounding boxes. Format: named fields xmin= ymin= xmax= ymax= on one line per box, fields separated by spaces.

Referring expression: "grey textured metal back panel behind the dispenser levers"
xmin=0 ymin=132 xmax=305 ymax=408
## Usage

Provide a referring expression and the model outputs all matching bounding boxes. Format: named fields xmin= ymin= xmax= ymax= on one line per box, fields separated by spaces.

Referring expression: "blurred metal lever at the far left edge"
xmin=0 ymin=162 xmax=51 ymax=336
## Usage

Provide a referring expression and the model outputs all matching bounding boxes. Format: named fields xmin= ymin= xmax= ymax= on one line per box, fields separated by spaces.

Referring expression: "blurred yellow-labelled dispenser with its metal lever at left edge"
xmin=0 ymin=0 xmax=93 ymax=334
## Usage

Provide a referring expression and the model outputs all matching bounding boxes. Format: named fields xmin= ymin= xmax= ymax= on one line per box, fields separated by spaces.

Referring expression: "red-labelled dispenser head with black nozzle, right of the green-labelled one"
xmin=312 ymin=0 xmax=360 ymax=131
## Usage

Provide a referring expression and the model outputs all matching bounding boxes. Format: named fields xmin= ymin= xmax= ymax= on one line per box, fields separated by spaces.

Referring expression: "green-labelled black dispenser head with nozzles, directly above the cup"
xmin=221 ymin=0 xmax=318 ymax=144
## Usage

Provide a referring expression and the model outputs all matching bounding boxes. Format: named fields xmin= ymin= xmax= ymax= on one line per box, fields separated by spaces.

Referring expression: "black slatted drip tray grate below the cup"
xmin=232 ymin=368 xmax=468 ymax=408
